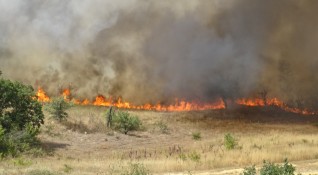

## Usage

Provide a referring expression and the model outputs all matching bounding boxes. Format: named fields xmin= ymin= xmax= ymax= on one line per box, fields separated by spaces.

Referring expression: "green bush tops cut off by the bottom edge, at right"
xmin=243 ymin=159 xmax=296 ymax=175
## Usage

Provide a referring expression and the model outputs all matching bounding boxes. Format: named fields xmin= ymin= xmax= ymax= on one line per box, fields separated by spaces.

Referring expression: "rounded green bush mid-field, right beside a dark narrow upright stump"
xmin=113 ymin=111 xmax=142 ymax=134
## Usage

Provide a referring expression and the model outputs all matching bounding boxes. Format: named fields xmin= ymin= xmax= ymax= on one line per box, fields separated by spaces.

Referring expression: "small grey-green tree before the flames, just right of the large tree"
xmin=45 ymin=97 xmax=73 ymax=122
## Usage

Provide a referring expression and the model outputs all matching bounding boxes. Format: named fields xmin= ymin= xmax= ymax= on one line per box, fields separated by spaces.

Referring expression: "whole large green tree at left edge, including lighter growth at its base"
xmin=0 ymin=79 xmax=44 ymax=157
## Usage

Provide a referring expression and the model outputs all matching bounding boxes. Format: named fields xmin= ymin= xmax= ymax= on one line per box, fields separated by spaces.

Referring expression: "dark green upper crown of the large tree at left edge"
xmin=0 ymin=79 xmax=44 ymax=133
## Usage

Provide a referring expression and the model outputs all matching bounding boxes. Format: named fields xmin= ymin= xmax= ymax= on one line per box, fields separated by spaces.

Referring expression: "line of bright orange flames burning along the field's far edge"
xmin=37 ymin=87 xmax=315 ymax=115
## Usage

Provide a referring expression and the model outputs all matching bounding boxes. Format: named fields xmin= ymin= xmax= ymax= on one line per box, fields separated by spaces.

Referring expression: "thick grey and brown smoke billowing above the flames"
xmin=0 ymin=0 xmax=318 ymax=107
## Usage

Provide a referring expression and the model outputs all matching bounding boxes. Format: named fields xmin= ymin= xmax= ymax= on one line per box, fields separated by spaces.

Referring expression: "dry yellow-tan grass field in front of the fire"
xmin=0 ymin=106 xmax=318 ymax=175
